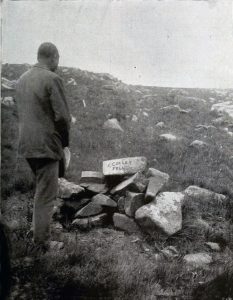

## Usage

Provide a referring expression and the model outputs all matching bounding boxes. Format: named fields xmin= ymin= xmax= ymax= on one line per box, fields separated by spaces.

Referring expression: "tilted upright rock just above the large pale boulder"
xmin=145 ymin=168 xmax=169 ymax=202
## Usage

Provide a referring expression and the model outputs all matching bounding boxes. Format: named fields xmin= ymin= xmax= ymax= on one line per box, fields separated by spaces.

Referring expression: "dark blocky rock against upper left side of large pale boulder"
xmin=124 ymin=192 xmax=144 ymax=217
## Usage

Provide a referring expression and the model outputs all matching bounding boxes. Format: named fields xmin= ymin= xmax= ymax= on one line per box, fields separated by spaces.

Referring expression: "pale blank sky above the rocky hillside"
xmin=2 ymin=0 xmax=233 ymax=88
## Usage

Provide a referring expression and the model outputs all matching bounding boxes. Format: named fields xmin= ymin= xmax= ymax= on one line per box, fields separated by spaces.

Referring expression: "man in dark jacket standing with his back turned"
xmin=16 ymin=43 xmax=70 ymax=250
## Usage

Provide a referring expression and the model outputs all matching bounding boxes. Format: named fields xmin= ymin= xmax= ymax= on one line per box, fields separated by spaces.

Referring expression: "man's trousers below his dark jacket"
xmin=27 ymin=158 xmax=59 ymax=244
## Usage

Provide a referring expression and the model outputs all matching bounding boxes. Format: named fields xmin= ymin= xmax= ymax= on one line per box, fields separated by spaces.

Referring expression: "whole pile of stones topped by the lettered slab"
xmin=54 ymin=157 xmax=225 ymax=236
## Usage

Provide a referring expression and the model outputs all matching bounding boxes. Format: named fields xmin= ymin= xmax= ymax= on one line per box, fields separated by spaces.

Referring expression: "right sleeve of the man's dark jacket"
xmin=50 ymin=76 xmax=71 ymax=147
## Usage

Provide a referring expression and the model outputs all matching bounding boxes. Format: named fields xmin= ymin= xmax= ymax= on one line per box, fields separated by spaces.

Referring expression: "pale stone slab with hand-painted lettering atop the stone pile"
xmin=103 ymin=156 xmax=147 ymax=176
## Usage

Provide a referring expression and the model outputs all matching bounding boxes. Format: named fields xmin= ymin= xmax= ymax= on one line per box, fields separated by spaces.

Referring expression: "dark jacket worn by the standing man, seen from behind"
xmin=16 ymin=64 xmax=70 ymax=160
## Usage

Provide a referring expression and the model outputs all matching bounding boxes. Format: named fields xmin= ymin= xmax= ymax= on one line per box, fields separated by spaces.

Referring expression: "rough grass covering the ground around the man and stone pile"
xmin=1 ymin=65 xmax=233 ymax=300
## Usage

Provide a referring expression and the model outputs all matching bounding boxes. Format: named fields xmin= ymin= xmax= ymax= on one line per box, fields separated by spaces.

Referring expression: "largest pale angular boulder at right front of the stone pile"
xmin=135 ymin=192 xmax=184 ymax=236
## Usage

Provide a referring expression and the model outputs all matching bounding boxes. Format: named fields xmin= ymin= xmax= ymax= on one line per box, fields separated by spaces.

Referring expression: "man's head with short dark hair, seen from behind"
xmin=37 ymin=43 xmax=59 ymax=72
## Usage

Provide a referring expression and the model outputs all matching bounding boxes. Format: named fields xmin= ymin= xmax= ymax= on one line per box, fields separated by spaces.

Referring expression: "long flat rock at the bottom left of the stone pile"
xmin=72 ymin=213 xmax=108 ymax=229
